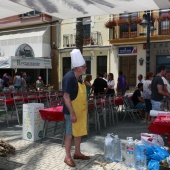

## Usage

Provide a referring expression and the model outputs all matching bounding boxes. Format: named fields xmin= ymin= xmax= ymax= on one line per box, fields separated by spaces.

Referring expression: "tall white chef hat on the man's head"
xmin=70 ymin=49 xmax=86 ymax=68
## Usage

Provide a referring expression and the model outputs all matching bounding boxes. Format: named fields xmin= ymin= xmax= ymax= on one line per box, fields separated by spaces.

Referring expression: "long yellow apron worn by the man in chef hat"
xmin=71 ymin=83 xmax=87 ymax=137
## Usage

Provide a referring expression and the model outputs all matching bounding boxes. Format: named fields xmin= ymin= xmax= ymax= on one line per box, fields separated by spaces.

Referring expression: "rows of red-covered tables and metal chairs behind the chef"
xmin=1 ymin=91 xmax=126 ymax=145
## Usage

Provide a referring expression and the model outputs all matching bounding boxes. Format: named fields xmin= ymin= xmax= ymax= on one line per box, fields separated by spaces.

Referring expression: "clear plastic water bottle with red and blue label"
xmin=125 ymin=137 xmax=135 ymax=168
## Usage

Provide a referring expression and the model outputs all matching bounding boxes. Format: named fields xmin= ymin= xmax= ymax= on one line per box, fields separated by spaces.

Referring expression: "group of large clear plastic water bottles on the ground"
xmin=104 ymin=134 xmax=147 ymax=170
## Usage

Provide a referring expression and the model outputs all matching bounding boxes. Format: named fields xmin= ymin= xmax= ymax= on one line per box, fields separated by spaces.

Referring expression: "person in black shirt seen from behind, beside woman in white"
xmin=92 ymin=73 xmax=108 ymax=95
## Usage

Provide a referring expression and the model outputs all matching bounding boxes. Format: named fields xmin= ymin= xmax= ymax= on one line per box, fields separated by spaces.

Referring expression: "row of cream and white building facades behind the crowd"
xmin=0 ymin=10 xmax=170 ymax=89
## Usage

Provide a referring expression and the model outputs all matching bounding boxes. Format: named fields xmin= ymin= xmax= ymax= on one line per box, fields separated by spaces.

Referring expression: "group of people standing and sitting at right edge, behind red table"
xmin=132 ymin=65 xmax=170 ymax=123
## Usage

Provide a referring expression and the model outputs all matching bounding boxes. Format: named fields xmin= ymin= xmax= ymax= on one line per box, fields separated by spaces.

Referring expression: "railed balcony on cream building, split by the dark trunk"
xmin=63 ymin=31 xmax=102 ymax=48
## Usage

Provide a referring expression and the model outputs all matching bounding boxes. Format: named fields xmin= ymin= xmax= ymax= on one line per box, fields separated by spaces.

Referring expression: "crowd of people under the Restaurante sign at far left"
xmin=0 ymin=72 xmax=44 ymax=92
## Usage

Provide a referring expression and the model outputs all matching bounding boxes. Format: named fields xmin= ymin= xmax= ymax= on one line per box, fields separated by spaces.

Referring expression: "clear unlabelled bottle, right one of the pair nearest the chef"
xmin=113 ymin=135 xmax=122 ymax=162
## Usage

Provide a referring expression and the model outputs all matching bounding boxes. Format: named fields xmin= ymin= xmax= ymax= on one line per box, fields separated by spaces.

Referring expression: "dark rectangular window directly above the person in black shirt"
xmin=97 ymin=56 xmax=107 ymax=74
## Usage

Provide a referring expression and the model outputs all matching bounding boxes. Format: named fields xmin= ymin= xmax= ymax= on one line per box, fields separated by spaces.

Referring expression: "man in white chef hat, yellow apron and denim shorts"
xmin=62 ymin=49 xmax=90 ymax=167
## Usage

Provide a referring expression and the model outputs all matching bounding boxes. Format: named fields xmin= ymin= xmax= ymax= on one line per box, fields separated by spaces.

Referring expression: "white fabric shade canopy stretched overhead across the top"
xmin=7 ymin=0 xmax=170 ymax=19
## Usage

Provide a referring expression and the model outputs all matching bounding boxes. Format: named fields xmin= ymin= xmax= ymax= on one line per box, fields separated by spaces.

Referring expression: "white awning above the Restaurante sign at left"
xmin=0 ymin=26 xmax=51 ymax=58
